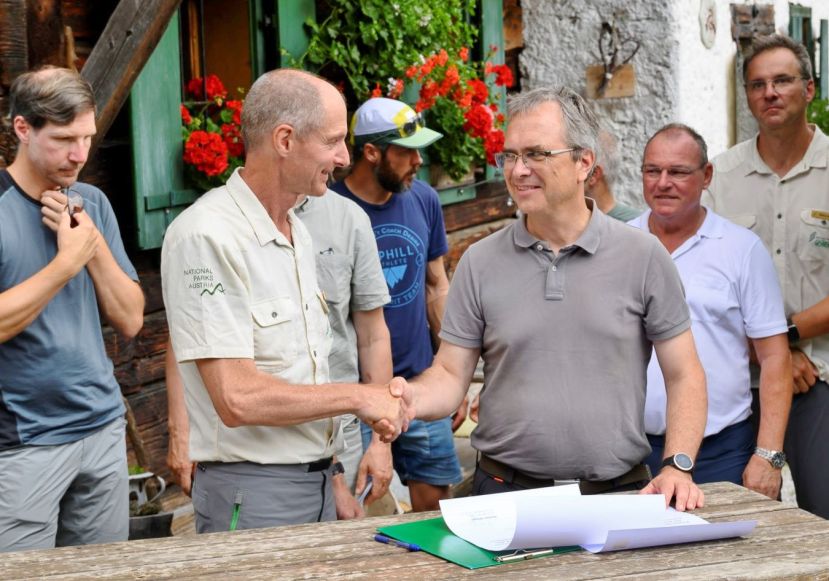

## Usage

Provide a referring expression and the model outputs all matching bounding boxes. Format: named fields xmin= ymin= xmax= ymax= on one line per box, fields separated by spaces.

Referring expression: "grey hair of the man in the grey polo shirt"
xmin=507 ymin=87 xmax=599 ymax=160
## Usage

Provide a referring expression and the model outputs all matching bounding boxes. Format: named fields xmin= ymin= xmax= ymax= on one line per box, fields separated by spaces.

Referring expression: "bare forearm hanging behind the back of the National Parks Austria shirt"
xmin=164 ymin=340 xmax=195 ymax=496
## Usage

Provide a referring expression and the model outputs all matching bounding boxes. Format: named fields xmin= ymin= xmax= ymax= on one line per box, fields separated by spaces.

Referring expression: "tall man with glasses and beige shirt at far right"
xmin=703 ymin=35 xmax=829 ymax=518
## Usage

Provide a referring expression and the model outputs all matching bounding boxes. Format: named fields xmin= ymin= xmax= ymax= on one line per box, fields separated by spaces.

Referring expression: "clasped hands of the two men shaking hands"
xmin=357 ymin=377 xmax=416 ymax=443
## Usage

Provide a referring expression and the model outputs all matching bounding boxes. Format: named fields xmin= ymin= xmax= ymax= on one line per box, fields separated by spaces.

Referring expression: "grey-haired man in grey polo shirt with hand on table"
xmin=405 ymin=88 xmax=707 ymax=510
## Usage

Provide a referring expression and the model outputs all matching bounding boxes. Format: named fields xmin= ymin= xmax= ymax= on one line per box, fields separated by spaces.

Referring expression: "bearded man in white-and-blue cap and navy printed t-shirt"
xmin=332 ymin=98 xmax=461 ymax=511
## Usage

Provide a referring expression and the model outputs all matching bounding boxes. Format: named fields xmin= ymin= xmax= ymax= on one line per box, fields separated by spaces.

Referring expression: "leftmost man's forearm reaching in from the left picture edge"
xmin=0 ymin=258 xmax=76 ymax=343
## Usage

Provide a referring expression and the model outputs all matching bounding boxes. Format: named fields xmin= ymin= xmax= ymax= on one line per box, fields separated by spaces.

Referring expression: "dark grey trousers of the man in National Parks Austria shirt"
xmin=192 ymin=462 xmax=337 ymax=533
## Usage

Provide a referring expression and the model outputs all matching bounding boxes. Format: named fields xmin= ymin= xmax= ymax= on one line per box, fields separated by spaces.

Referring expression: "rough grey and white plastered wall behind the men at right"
xmin=520 ymin=0 xmax=829 ymax=208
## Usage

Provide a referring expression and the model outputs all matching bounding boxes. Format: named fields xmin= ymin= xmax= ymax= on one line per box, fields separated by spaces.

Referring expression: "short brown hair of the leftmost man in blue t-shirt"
xmin=9 ymin=66 xmax=95 ymax=129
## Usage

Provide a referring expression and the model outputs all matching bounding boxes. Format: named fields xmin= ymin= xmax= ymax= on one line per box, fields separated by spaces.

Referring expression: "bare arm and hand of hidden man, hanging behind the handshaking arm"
xmin=351 ymin=307 xmax=393 ymax=504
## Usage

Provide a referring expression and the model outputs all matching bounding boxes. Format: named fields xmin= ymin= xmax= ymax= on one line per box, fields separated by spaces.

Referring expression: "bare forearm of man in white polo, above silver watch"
xmin=753 ymin=335 xmax=792 ymax=450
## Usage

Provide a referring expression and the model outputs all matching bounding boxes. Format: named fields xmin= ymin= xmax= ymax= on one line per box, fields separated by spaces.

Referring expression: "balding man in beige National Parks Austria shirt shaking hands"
xmin=161 ymin=69 xmax=405 ymax=532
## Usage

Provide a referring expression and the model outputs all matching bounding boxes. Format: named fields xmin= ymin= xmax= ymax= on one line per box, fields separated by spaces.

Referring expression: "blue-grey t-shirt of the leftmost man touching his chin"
xmin=0 ymin=171 xmax=138 ymax=451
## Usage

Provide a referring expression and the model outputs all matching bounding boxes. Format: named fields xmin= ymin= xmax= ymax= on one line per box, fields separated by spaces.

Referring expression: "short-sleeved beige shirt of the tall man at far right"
xmin=703 ymin=127 xmax=829 ymax=381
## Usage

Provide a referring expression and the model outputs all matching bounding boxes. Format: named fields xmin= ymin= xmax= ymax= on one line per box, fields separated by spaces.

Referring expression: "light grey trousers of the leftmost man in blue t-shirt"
xmin=0 ymin=418 xmax=129 ymax=551
